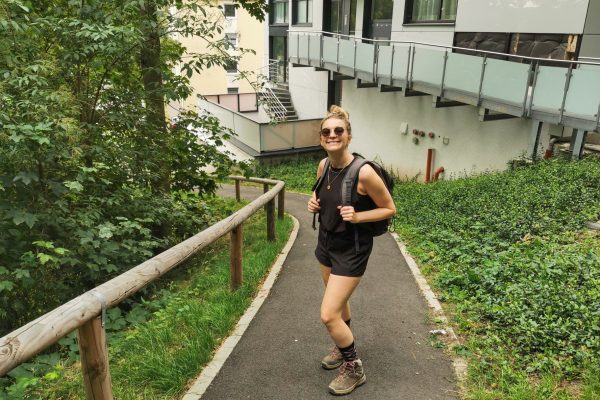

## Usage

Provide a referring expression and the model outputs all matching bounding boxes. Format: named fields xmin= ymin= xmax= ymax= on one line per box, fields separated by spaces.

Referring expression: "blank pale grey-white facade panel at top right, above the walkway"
xmin=456 ymin=0 xmax=597 ymax=33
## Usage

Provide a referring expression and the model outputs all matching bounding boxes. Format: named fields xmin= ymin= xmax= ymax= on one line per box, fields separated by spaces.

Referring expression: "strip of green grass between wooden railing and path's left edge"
xmin=30 ymin=214 xmax=292 ymax=399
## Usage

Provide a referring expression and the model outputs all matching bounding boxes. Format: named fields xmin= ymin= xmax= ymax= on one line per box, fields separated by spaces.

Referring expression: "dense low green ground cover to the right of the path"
xmin=396 ymin=157 xmax=600 ymax=390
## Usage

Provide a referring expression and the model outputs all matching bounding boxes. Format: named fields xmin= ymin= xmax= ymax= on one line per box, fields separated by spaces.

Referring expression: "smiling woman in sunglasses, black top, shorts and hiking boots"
xmin=308 ymin=105 xmax=396 ymax=394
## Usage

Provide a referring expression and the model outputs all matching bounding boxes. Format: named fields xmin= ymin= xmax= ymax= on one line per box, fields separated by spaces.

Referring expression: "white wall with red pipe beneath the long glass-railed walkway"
xmin=342 ymin=80 xmax=536 ymax=181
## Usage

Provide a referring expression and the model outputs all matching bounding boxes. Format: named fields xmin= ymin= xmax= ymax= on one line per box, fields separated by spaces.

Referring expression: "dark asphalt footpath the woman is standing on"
xmin=202 ymin=186 xmax=458 ymax=400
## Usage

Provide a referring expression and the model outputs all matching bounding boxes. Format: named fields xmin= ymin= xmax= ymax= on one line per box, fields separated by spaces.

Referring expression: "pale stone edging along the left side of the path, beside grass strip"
xmin=181 ymin=214 xmax=300 ymax=400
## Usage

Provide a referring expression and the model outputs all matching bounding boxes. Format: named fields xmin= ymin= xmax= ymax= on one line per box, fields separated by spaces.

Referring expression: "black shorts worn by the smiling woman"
xmin=315 ymin=229 xmax=373 ymax=277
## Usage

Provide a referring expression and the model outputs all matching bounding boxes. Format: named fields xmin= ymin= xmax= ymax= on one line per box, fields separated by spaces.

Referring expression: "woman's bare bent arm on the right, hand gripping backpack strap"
xmin=339 ymin=164 xmax=396 ymax=224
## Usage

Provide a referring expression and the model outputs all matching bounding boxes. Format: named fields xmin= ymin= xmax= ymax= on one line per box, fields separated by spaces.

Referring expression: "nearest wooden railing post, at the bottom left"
xmin=77 ymin=317 xmax=113 ymax=400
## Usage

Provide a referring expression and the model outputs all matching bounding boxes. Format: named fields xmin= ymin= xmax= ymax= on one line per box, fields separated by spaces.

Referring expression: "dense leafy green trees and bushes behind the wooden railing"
xmin=0 ymin=0 xmax=264 ymax=335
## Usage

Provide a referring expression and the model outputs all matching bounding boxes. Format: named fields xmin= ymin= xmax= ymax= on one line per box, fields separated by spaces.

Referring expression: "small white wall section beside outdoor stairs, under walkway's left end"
xmin=289 ymin=65 xmax=328 ymax=119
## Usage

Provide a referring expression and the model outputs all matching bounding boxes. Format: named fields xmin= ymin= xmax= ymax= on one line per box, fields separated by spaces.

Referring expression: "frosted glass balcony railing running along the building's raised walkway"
xmin=288 ymin=31 xmax=600 ymax=131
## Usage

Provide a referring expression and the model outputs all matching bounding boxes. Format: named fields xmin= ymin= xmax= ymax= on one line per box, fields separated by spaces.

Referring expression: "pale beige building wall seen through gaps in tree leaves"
xmin=177 ymin=1 xmax=268 ymax=107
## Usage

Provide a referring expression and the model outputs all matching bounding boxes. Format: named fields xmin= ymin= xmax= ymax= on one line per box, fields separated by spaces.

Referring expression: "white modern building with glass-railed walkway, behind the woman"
xmin=282 ymin=0 xmax=600 ymax=180
